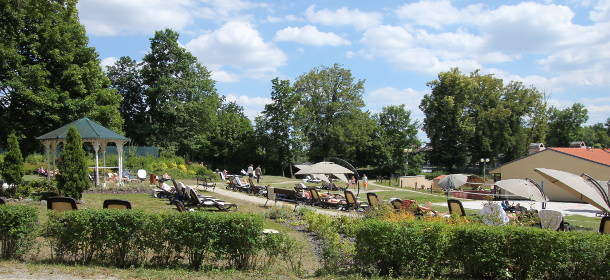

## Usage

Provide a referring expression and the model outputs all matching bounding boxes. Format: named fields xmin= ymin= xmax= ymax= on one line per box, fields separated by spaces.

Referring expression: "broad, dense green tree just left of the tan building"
xmin=420 ymin=68 xmax=547 ymax=170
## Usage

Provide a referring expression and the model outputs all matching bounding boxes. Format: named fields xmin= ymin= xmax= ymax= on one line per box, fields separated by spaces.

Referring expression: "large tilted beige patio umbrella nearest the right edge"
xmin=534 ymin=168 xmax=610 ymax=212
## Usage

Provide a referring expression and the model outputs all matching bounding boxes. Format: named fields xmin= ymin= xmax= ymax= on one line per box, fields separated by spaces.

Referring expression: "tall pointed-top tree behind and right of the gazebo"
xmin=109 ymin=29 xmax=221 ymax=159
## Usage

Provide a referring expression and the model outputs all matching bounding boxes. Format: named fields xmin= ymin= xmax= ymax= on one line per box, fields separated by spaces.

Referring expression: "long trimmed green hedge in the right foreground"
xmin=355 ymin=220 xmax=610 ymax=279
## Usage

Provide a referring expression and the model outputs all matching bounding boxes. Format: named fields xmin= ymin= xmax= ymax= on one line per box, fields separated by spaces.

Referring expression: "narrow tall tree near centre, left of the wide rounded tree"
xmin=256 ymin=78 xmax=304 ymax=176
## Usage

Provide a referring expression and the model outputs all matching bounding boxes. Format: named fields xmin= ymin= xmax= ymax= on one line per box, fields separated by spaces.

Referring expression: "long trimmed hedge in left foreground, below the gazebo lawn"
xmin=44 ymin=209 xmax=263 ymax=269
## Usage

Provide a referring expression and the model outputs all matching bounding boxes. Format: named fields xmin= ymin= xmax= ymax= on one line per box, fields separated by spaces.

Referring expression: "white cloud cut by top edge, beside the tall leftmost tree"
xmin=78 ymin=0 xmax=193 ymax=36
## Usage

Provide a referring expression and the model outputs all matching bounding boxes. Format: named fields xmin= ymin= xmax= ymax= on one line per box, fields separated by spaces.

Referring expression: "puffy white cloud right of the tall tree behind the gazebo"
xmin=186 ymin=21 xmax=287 ymax=79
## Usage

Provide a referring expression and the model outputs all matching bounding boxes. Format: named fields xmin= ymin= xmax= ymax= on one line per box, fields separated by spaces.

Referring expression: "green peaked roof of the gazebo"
xmin=36 ymin=117 xmax=129 ymax=142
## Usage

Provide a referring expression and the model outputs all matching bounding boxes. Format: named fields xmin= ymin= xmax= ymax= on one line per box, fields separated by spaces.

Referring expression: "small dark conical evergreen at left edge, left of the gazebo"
xmin=1 ymin=133 xmax=25 ymax=186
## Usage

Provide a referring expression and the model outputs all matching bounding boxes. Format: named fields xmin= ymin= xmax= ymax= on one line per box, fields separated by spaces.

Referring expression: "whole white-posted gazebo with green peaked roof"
xmin=36 ymin=118 xmax=129 ymax=187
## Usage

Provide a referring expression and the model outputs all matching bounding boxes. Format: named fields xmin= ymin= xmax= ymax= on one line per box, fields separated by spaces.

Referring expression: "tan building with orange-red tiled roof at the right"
xmin=489 ymin=142 xmax=610 ymax=202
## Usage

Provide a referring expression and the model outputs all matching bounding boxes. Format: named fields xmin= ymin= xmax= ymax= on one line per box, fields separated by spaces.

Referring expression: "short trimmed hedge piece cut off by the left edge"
xmin=0 ymin=205 xmax=38 ymax=259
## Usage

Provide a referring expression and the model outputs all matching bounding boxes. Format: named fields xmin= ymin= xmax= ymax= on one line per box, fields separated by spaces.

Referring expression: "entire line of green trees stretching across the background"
xmin=0 ymin=0 xmax=610 ymax=175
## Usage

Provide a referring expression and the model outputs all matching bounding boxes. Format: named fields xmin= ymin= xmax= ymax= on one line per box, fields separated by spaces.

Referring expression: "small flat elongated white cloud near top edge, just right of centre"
xmin=305 ymin=5 xmax=382 ymax=29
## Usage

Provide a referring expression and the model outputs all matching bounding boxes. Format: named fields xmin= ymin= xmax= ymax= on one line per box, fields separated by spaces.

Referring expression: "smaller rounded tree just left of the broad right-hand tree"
xmin=364 ymin=105 xmax=423 ymax=175
